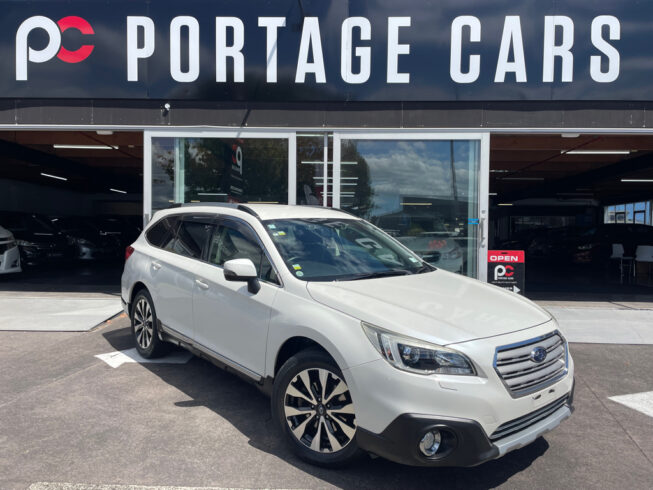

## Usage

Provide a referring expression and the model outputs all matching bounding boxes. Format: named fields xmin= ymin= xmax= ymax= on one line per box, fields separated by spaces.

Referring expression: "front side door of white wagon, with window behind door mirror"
xmin=193 ymin=218 xmax=280 ymax=375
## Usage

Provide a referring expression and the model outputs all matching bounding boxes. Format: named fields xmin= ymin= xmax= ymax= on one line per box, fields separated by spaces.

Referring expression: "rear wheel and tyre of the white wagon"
xmin=131 ymin=289 xmax=168 ymax=359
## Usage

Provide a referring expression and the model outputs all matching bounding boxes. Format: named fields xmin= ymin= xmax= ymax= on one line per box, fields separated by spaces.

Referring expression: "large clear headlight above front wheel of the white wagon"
xmin=361 ymin=322 xmax=476 ymax=376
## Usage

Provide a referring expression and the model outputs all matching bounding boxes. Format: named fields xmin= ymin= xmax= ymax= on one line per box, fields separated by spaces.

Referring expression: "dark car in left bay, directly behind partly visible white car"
xmin=0 ymin=211 xmax=73 ymax=265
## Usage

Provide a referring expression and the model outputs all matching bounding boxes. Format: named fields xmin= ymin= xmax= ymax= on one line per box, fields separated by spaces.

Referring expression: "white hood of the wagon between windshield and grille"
xmin=307 ymin=269 xmax=551 ymax=345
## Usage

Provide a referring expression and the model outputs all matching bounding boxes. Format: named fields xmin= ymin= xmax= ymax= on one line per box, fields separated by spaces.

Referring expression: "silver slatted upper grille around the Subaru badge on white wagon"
xmin=494 ymin=331 xmax=567 ymax=397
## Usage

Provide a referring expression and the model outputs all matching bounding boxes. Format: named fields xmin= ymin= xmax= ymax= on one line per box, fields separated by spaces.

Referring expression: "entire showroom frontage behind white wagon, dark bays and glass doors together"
xmin=0 ymin=128 xmax=653 ymax=299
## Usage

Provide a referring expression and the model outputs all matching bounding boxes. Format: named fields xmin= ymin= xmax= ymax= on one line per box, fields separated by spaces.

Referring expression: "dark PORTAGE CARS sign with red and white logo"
xmin=0 ymin=0 xmax=653 ymax=101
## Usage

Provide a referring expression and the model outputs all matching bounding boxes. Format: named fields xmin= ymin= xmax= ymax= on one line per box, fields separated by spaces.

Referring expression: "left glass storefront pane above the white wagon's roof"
xmin=152 ymin=137 xmax=288 ymax=211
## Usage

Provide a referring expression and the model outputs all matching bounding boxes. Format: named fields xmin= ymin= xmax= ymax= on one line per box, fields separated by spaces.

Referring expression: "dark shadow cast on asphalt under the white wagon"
xmin=103 ymin=328 xmax=549 ymax=489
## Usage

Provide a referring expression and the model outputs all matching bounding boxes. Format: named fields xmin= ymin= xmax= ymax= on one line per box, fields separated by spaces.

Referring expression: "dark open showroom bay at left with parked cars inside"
xmin=0 ymin=130 xmax=143 ymax=292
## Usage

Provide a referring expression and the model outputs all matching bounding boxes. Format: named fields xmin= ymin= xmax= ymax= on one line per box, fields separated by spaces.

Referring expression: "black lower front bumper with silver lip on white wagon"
xmin=356 ymin=387 xmax=574 ymax=466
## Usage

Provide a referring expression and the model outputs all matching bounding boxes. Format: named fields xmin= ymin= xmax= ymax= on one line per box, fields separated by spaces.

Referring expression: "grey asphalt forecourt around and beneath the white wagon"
xmin=0 ymin=316 xmax=653 ymax=490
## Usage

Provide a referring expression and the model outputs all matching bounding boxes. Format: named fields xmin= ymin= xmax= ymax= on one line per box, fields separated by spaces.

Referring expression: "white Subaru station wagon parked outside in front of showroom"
xmin=121 ymin=204 xmax=574 ymax=466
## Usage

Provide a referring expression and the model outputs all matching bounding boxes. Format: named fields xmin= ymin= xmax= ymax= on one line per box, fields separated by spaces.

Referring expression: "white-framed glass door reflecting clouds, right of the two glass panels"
xmin=334 ymin=131 xmax=489 ymax=280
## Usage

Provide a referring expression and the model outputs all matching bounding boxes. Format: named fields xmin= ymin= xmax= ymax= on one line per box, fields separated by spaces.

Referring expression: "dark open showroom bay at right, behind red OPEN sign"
xmin=489 ymin=132 xmax=653 ymax=298
